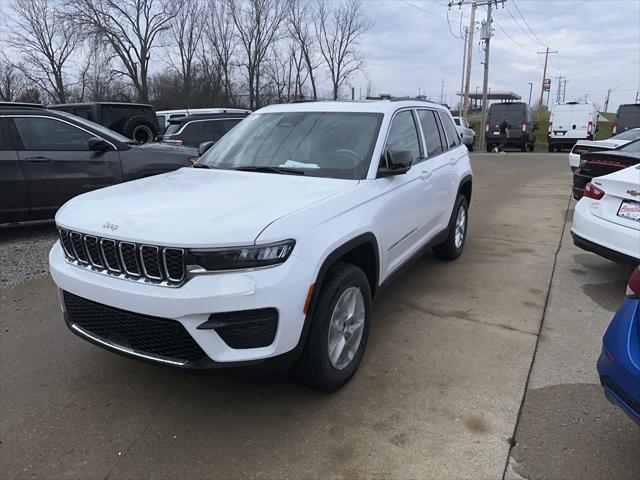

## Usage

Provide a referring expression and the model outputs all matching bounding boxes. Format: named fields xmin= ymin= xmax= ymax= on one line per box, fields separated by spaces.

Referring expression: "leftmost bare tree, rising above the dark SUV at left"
xmin=5 ymin=0 xmax=80 ymax=103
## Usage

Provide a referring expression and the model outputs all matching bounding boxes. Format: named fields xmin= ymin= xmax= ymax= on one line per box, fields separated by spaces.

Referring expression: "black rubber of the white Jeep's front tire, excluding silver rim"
xmin=291 ymin=262 xmax=371 ymax=392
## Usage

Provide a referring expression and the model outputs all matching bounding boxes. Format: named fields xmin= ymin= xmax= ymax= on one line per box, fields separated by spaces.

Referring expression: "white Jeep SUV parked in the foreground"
xmin=49 ymin=100 xmax=472 ymax=391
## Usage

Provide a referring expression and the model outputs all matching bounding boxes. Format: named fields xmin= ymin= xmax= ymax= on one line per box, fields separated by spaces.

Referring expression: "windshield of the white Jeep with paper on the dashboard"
xmin=198 ymin=112 xmax=383 ymax=180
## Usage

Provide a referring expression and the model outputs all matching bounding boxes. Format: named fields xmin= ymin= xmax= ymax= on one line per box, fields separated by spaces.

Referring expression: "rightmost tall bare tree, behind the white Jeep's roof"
xmin=315 ymin=0 xmax=373 ymax=100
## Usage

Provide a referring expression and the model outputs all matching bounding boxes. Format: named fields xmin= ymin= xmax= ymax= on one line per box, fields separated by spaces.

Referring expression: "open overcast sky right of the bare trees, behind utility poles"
xmin=351 ymin=0 xmax=640 ymax=111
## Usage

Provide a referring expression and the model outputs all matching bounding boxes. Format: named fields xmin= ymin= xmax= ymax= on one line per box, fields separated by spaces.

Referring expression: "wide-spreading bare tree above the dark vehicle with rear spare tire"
xmin=65 ymin=0 xmax=183 ymax=102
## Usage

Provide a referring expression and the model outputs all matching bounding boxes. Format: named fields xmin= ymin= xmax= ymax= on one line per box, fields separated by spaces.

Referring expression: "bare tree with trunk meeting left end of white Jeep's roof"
xmin=227 ymin=0 xmax=289 ymax=109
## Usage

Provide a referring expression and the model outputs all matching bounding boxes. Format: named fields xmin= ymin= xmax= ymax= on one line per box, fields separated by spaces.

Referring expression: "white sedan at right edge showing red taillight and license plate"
xmin=571 ymin=165 xmax=640 ymax=265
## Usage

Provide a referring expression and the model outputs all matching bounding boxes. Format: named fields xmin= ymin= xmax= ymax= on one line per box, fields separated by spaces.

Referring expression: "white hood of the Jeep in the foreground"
xmin=56 ymin=168 xmax=358 ymax=248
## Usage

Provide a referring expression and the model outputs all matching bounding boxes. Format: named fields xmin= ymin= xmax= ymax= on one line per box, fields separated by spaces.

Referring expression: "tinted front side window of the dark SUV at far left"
xmin=13 ymin=117 xmax=93 ymax=151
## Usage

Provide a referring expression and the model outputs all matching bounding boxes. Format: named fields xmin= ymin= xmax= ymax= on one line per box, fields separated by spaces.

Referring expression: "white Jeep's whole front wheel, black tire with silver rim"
xmin=292 ymin=263 xmax=371 ymax=392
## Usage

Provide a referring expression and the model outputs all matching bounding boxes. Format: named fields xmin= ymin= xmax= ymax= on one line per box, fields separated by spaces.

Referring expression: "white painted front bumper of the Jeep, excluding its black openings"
xmin=49 ymin=242 xmax=314 ymax=368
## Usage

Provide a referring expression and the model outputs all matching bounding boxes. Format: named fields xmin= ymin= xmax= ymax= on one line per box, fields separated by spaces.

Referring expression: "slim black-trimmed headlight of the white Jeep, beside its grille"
xmin=185 ymin=240 xmax=296 ymax=271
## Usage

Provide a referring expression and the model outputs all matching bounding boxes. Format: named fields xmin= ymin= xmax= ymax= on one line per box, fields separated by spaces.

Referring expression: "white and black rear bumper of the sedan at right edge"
xmin=571 ymin=198 xmax=640 ymax=265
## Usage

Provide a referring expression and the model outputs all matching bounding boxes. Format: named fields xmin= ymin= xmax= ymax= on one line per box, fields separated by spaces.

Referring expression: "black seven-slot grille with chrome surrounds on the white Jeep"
xmin=58 ymin=228 xmax=186 ymax=287
